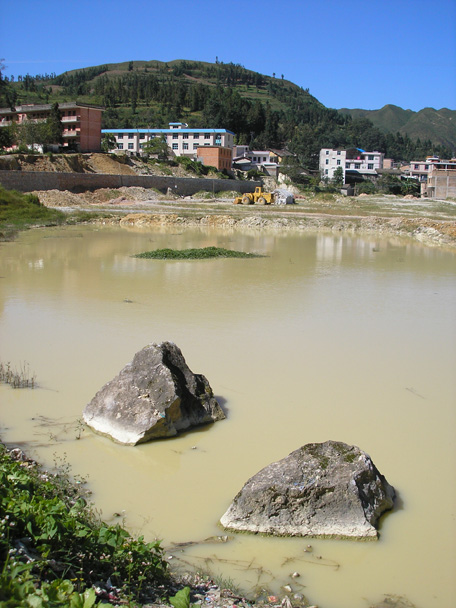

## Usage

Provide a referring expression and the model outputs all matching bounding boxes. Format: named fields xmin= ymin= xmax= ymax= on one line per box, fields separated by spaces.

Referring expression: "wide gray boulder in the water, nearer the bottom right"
xmin=220 ymin=441 xmax=395 ymax=538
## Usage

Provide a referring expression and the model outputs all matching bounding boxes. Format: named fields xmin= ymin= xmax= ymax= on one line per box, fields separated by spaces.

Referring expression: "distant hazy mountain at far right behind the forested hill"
xmin=339 ymin=104 xmax=456 ymax=152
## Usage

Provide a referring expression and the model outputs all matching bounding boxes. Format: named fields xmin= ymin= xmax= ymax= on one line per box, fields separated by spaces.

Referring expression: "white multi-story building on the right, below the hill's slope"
xmin=320 ymin=148 xmax=384 ymax=182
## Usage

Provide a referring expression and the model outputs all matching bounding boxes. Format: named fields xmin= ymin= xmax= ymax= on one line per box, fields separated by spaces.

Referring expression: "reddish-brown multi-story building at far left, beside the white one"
xmin=0 ymin=102 xmax=104 ymax=152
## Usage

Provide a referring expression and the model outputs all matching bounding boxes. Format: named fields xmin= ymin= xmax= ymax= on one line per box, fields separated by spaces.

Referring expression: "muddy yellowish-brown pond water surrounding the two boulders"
xmin=0 ymin=227 xmax=456 ymax=608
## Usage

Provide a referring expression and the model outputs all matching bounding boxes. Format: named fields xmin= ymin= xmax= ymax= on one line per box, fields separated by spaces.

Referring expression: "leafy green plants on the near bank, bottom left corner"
xmin=0 ymin=444 xmax=168 ymax=608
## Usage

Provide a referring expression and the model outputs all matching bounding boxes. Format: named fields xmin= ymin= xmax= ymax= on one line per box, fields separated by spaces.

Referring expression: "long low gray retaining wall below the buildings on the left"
xmin=0 ymin=171 xmax=261 ymax=196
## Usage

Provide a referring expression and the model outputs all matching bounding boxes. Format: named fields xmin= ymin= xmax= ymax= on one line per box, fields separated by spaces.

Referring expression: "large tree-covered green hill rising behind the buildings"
xmin=0 ymin=60 xmax=456 ymax=169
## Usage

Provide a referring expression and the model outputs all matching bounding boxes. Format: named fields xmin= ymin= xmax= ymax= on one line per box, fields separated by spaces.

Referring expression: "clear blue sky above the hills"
xmin=0 ymin=0 xmax=456 ymax=111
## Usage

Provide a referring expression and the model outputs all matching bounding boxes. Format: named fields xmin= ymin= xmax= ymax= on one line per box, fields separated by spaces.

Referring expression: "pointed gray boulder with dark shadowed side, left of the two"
xmin=83 ymin=342 xmax=225 ymax=445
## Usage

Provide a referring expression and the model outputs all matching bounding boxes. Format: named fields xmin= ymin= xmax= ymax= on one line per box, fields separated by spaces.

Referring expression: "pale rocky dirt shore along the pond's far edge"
xmin=34 ymin=187 xmax=456 ymax=250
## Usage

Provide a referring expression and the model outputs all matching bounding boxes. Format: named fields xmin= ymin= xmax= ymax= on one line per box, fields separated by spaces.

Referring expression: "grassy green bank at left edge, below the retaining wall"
xmin=0 ymin=186 xmax=66 ymax=240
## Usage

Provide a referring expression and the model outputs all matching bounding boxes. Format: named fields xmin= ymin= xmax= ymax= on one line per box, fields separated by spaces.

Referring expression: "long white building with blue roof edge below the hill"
xmin=102 ymin=122 xmax=234 ymax=158
